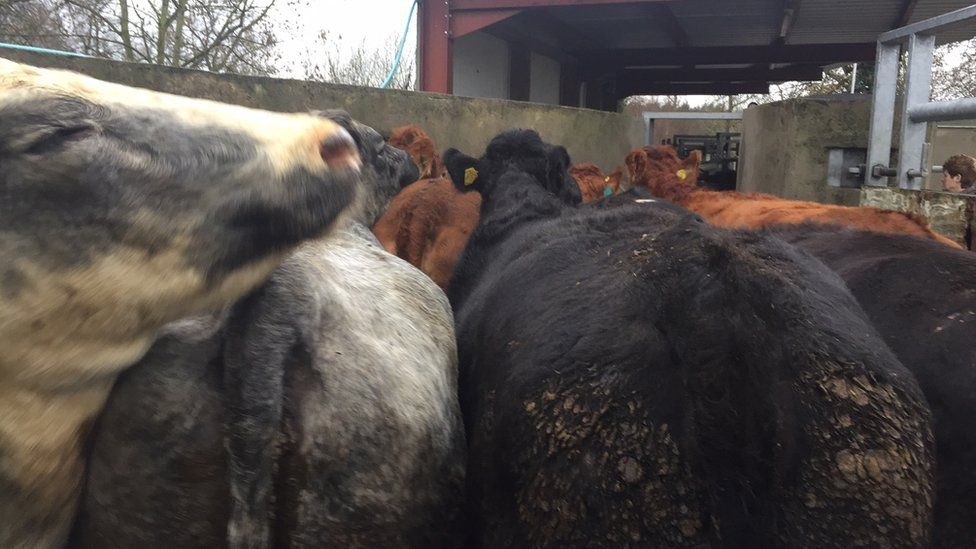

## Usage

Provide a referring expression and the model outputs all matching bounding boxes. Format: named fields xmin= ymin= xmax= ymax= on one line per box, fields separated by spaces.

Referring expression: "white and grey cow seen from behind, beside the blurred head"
xmin=73 ymin=112 xmax=464 ymax=548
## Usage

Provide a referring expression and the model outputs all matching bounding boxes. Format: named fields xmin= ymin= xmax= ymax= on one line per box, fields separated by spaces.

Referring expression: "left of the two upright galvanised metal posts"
xmin=864 ymin=43 xmax=901 ymax=187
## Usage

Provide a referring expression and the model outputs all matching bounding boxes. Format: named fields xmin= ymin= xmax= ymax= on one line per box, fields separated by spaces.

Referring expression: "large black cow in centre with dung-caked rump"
xmin=444 ymin=130 xmax=934 ymax=547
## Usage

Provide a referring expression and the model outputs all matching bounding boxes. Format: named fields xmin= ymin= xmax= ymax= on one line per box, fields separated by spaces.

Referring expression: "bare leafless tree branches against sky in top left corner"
xmin=0 ymin=0 xmax=286 ymax=74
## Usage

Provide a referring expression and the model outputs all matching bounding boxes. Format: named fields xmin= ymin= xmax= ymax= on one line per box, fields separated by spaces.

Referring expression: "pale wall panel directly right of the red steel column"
xmin=453 ymin=32 xmax=510 ymax=99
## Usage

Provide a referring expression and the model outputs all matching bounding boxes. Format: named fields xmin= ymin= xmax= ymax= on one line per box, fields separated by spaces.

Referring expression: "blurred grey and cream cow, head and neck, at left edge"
xmin=0 ymin=59 xmax=360 ymax=549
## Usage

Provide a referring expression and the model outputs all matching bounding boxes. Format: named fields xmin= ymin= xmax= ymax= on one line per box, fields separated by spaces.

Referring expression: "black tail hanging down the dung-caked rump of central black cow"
xmin=654 ymin=227 xmax=800 ymax=546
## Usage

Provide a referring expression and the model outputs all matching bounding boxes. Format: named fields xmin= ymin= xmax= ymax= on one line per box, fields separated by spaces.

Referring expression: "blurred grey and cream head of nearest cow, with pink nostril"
xmin=0 ymin=59 xmax=360 ymax=374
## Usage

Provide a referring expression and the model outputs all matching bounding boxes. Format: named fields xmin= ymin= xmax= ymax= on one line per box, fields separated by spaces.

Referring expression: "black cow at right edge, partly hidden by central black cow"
xmin=772 ymin=224 xmax=976 ymax=547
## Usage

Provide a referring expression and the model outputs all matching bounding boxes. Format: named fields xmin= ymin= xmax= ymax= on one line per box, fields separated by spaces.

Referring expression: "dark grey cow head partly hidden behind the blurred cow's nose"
xmin=316 ymin=110 xmax=420 ymax=227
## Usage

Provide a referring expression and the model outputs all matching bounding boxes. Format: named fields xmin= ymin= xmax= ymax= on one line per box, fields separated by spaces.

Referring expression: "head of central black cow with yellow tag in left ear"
xmin=444 ymin=130 xmax=582 ymax=205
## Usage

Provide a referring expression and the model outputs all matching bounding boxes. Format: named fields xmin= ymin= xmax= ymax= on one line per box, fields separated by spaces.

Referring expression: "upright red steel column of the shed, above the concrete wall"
xmin=418 ymin=0 xmax=454 ymax=93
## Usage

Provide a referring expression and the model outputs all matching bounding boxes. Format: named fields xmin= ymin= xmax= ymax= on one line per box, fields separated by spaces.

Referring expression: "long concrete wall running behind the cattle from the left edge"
xmin=0 ymin=50 xmax=642 ymax=170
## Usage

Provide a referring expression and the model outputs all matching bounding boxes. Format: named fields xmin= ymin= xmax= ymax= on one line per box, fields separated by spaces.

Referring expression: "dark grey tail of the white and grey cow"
xmin=224 ymin=280 xmax=297 ymax=549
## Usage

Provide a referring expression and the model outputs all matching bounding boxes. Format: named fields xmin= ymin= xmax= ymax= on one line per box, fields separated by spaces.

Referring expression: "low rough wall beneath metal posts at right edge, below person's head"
xmin=860 ymin=187 xmax=976 ymax=250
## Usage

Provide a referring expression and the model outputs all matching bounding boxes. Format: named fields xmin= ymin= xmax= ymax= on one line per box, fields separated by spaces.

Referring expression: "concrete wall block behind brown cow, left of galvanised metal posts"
xmin=737 ymin=95 xmax=898 ymax=206
